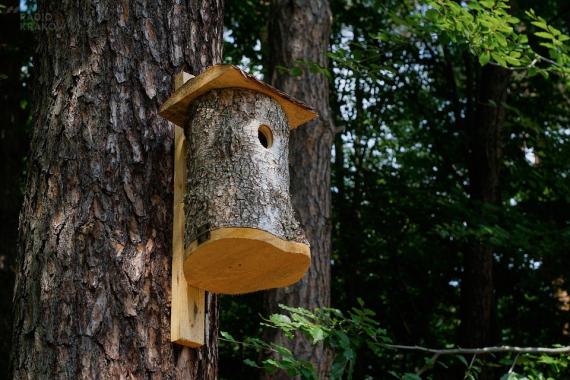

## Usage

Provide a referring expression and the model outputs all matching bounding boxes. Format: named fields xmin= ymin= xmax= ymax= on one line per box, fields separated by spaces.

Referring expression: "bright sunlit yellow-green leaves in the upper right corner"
xmin=422 ymin=0 xmax=570 ymax=77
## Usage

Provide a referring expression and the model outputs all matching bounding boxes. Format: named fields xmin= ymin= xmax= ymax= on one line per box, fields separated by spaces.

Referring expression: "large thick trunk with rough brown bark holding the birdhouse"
xmin=12 ymin=0 xmax=223 ymax=379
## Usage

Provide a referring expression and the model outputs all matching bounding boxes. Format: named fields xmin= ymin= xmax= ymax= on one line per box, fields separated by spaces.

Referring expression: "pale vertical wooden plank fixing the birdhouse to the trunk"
xmin=170 ymin=71 xmax=206 ymax=347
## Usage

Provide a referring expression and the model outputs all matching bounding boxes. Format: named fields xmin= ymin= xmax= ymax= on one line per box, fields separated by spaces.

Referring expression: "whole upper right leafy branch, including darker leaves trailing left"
xmin=329 ymin=0 xmax=570 ymax=79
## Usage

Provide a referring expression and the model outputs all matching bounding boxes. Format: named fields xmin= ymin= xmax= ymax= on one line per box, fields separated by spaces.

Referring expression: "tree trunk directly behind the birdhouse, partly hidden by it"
xmin=265 ymin=0 xmax=335 ymax=379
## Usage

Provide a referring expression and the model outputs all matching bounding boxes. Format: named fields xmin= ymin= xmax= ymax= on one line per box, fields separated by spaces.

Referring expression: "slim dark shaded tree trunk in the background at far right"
xmin=459 ymin=65 xmax=510 ymax=347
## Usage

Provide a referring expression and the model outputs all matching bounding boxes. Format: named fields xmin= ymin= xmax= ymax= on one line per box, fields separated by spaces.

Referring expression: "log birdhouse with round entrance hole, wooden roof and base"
xmin=160 ymin=65 xmax=317 ymax=348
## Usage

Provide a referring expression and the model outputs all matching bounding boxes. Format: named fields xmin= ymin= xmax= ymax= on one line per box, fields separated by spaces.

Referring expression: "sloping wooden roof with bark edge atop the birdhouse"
xmin=159 ymin=65 xmax=319 ymax=128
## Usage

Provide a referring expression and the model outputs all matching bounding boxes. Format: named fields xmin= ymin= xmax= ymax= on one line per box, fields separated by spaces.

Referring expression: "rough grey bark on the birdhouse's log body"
xmin=184 ymin=89 xmax=307 ymax=245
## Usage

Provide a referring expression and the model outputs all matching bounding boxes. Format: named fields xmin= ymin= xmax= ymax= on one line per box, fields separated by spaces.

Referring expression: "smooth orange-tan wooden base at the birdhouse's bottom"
xmin=184 ymin=228 xmax=311 ymax=294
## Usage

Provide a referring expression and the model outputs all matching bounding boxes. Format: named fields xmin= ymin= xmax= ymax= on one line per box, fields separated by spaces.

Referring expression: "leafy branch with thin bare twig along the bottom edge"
xmin=220 ymin=301 xmax=570 ymax=380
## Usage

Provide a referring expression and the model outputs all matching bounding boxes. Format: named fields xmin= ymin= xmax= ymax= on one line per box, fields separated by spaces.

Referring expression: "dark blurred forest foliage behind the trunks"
xmin=221 ymin=0 xmax=570 ymax=378
